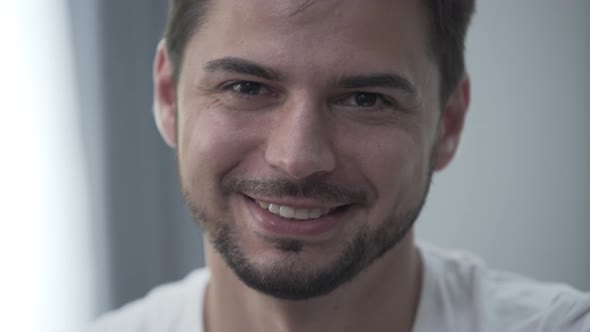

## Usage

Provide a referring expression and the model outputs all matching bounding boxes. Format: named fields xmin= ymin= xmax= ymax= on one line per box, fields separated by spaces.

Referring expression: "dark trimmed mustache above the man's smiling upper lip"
xmin=221 ymin=177 xmax=368 ymax=205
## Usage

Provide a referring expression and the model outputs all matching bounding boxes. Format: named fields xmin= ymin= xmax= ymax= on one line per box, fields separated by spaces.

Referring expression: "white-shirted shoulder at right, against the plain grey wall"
xmin=419 ymin=244 xmax=590 ymax=332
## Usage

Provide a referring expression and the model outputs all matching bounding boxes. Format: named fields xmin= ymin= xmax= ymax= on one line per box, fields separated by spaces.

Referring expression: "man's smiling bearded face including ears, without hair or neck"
xmin=155 ymin=0 xmax=464 ymax=299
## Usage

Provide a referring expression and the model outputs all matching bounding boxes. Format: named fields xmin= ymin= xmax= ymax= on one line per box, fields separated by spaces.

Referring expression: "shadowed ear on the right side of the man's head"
xmin=434 ymin=75 xmax=471 ymax=171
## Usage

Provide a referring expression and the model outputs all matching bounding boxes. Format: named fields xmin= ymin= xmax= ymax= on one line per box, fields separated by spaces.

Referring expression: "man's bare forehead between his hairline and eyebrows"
xmin=187 ymin=0 xmax=438 ymax=88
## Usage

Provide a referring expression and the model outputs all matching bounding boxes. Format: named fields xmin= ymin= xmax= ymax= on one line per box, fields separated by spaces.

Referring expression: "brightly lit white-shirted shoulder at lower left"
xmin=89 ymin=269 xmax=209 ymax=332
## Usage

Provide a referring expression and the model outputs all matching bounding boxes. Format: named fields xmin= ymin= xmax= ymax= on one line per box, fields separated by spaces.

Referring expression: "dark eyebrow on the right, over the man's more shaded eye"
xmin=335 ymin=74 xmax=416 ymax=95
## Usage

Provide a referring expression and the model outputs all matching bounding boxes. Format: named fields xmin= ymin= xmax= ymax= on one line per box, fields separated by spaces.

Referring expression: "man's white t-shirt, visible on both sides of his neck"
xmin=91 ymin=245 xmax=590 ymax=332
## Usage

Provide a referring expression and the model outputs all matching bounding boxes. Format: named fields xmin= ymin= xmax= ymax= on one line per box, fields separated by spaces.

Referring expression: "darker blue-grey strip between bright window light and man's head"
xmin=101 ymin=0 xmax=202 ymax=312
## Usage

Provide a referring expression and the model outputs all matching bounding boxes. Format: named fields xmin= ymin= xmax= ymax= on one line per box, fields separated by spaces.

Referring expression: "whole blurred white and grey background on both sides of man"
xmin=0 ymin=0 xmax=590 ymax=332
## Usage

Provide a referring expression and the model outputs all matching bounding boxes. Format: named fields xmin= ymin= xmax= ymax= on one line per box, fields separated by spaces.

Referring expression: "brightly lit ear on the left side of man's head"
xmin=154 ymin=39 xmax=177 ymax=148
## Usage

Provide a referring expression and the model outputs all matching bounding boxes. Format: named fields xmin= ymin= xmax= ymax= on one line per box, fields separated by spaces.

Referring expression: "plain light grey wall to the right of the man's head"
xmin=418 ymin=0 xmax=590 ymax=291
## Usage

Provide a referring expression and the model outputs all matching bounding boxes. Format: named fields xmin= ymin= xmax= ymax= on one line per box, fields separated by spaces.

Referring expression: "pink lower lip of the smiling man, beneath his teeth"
xmin=244 ymin=197 xmax=348 ymax=238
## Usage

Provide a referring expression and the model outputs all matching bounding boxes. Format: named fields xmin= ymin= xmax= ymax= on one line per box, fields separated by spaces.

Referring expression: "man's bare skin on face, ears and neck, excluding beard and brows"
xmin=154 ymin=0 xmax=469 ymax=331
